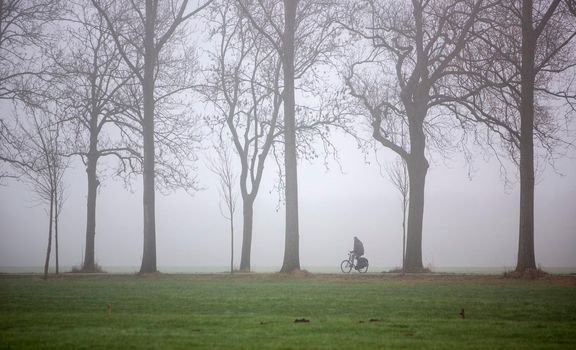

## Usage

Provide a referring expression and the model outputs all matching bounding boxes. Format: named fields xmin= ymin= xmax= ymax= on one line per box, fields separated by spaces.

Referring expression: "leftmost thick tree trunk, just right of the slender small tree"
xmin=82 ymin=150 xmax=98 ymax=272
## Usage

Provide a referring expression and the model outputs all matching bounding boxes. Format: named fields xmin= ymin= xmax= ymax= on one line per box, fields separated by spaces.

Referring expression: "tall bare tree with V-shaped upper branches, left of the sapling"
xmin=92 ymin=0 xmax=210 ymax=273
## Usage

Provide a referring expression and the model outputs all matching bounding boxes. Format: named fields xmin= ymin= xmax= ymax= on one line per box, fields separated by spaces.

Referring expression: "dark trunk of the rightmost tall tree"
xmin=516 ymin=0 xmax=536 ymax=272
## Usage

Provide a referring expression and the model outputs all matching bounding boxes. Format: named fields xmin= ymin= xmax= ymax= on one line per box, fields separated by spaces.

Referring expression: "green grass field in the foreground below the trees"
xmin=0 ymin=274 xmax=576 ymax=349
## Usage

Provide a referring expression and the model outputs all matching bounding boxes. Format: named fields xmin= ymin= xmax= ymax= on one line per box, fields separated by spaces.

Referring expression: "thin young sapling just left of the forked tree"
xmin=208 ymin=144 xmax=238 ymax=273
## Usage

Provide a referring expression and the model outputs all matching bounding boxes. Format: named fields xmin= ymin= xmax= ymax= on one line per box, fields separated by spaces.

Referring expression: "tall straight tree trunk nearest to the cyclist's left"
xmin=281 ymin=0 xmax=300 ymax=272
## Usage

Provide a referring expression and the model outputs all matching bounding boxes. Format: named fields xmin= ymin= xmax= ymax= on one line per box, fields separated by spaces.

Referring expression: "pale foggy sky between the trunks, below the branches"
xmin=0 ymin=131 xmax=576 ymax=272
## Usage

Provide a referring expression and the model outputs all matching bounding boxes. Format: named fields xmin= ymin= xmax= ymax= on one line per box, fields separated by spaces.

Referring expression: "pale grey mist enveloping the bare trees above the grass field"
xmin=0 ymin=0 xmax=576 ymax=275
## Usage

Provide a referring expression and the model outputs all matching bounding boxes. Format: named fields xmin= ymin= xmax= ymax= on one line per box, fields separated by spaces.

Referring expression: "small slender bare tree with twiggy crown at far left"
xmin=13 ymin=109 xmax=68 ymax=278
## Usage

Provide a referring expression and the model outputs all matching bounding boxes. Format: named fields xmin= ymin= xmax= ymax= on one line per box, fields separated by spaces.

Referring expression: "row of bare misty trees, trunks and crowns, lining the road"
xmin=0 ymin=0 xmax=576 ymax=274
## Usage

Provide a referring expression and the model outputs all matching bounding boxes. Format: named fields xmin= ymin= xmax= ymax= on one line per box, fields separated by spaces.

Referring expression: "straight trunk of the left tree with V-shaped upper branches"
xmin=140 ymin=0 xmax=158 ymax=273
